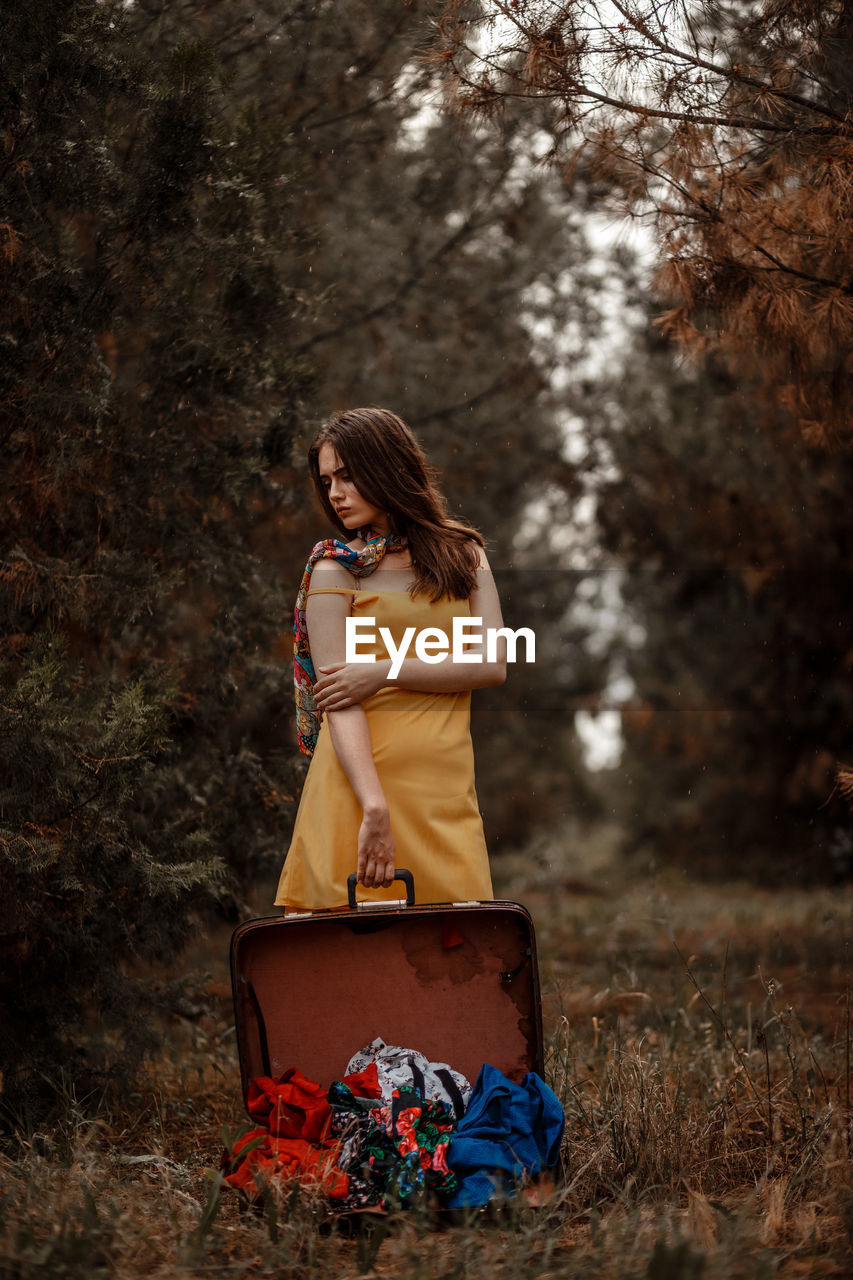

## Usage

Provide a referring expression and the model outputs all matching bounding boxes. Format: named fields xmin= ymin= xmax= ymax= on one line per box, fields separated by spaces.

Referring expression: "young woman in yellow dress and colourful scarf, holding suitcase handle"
xmin=275 ymin=408 xmax=506 ymax=910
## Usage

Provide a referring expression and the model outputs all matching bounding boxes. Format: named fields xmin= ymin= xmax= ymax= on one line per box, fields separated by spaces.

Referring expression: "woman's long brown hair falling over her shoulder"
xmin=309 ymin=408 xmax=483 ymax=600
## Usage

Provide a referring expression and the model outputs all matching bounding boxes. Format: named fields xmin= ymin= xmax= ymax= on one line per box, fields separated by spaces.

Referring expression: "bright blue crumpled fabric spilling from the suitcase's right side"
xmin=443 ymin=1062 xmax=565 ymax=1208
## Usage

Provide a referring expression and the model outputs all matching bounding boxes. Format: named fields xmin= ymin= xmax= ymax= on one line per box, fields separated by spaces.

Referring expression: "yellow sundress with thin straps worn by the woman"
xmin=275 ymin=589 xmax=493 ymax=910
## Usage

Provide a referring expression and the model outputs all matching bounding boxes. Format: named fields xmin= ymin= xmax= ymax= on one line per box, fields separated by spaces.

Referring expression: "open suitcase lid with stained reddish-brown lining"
xmin=231 ymin=902 xmax=543 ymax=1098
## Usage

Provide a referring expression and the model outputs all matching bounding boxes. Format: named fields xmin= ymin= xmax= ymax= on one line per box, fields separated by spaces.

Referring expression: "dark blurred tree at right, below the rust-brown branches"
xmin=578 ymin=322 xmax=853 ymax=881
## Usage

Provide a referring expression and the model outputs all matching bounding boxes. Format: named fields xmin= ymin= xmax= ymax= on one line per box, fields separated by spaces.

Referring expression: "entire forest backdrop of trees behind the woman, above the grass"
xmin=0 ymin=0 xmax=853 ymax=1097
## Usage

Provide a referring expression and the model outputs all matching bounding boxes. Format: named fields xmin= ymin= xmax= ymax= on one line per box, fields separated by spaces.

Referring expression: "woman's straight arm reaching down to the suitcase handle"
xmin=305 ymin=559 xmax=394 ymax=888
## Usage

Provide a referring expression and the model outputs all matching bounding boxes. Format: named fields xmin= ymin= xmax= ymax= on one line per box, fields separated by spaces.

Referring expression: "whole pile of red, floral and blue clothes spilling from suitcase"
xmin=222 ymin=1041 xmax=565 ymax=1212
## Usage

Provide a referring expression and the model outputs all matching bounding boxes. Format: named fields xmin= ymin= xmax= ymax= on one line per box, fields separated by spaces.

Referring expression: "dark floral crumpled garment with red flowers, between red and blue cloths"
xmin=329 ymin=1082 xmax=456 ymax=1208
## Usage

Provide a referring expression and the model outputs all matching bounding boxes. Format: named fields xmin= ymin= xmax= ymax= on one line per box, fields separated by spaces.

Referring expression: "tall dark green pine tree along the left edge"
xmin=0 ymin=0 xmax=306 ymax=1101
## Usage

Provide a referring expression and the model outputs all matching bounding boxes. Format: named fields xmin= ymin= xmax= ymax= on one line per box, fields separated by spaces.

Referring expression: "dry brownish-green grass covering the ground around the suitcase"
xmin=0 ymin=856 xmax=853 ymax=1280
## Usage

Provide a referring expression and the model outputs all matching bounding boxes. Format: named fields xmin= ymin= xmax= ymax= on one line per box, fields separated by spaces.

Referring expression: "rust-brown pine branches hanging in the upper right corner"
xmin=437 ymin=0 xmax=853 ymax=445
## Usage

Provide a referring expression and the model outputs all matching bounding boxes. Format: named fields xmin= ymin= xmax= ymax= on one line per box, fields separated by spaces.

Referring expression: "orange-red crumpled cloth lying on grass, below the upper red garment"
xmin=222 ymin=1129 xmax=350 ymax=1201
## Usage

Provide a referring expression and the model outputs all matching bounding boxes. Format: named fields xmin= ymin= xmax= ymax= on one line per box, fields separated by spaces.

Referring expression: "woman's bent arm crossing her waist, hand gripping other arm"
xmin=314 ymin=550 xmax=506 ymax=710
